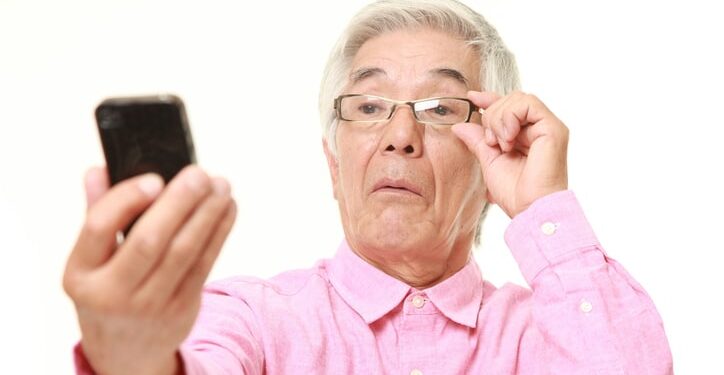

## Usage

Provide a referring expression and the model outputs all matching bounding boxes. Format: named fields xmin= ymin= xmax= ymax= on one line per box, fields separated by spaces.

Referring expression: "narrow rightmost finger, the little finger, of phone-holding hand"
xmin=173 ymin=200 xmax=237 ymax=306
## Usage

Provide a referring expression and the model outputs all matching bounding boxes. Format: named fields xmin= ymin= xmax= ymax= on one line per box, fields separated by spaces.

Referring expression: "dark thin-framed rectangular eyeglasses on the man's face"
xmin=334 ymin=94 xmax=478 ymax=125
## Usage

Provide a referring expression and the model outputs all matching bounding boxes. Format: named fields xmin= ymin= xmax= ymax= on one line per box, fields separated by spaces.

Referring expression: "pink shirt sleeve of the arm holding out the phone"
xmin=180 ymin=286 xmax=264 ymax=375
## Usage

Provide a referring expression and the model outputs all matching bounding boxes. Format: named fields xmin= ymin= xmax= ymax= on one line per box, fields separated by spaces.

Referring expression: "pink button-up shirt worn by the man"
xmin=77 ymin=191 xmax=673 ymax=375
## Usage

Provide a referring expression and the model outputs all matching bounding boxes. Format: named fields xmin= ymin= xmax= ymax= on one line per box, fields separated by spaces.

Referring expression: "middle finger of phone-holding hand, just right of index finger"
xmin=109 ymin=166 xmax=211 ymax=290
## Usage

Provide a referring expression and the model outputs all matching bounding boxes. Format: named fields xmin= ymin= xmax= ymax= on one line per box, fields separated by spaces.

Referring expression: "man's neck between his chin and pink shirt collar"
xmin=349 ymin=240 xmax=472 ymax=290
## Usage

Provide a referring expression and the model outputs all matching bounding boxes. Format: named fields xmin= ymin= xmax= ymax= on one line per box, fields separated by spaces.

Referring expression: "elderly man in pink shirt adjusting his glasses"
xmin=64 ymin=0 xmax=671 ymax=375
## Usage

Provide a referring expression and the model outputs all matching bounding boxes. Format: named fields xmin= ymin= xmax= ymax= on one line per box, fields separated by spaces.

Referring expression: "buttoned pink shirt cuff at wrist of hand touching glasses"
xmin=505 ymin=190 xmax=605 ymax=285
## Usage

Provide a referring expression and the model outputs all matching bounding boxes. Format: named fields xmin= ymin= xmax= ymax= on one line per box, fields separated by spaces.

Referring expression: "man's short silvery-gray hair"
xmin=319 ymin=0 xmax=520 ymax=245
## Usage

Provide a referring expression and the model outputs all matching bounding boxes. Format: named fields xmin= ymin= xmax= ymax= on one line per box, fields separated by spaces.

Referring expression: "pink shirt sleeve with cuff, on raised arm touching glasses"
xmin=505 ymin=191 xmax=673 ymax=375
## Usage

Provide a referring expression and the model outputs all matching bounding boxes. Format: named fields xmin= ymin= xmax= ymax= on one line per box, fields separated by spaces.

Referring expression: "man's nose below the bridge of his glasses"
xmin=379 ymin=105 xmax=425 ymax=158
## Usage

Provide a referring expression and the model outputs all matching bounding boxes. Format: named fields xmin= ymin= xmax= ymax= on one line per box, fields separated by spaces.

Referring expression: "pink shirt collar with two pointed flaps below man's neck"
xmin=329 ymin=241 xmax=483 ymax=328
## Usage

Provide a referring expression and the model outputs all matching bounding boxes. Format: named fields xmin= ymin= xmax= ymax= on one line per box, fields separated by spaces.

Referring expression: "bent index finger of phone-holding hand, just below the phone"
xmin=68 ymin=174 xmax=163 ymax=269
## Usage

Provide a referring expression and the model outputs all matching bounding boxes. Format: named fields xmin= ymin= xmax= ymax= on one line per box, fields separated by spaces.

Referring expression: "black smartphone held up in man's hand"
xmin=95 ymin=95 xmax=196 ymax=185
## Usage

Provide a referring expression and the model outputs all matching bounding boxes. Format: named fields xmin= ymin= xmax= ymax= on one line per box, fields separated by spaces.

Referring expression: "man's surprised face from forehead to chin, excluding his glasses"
xmin=325 ymin=29 xmax=485 ymax=255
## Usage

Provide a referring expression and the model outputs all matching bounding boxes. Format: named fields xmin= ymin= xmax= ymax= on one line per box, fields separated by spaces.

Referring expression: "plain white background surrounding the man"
xmin=0 ymin=0 xmax=724 ymax=374
